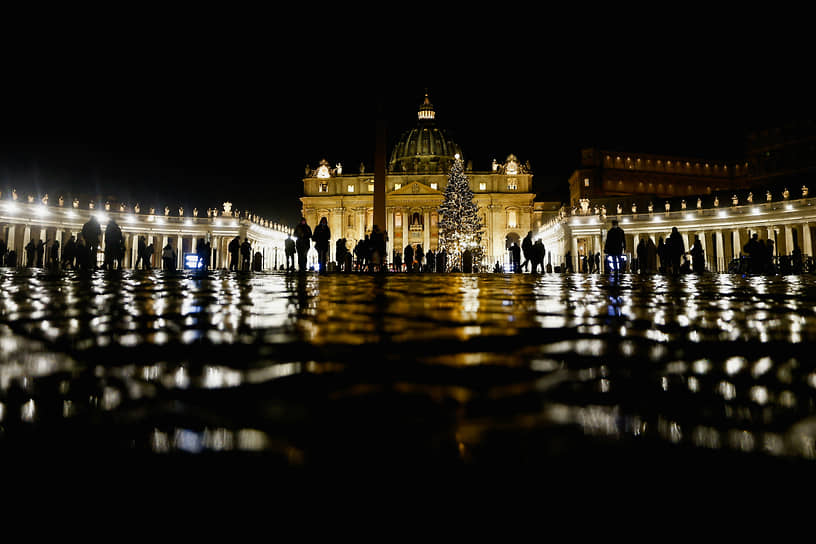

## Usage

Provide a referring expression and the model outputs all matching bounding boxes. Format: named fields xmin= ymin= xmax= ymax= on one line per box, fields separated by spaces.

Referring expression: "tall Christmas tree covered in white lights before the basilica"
xmin=439 ymin=155 xmax=483 ymax=270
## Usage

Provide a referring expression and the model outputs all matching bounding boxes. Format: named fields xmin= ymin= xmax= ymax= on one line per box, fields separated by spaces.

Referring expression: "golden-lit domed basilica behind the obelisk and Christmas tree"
xmin=301 ymin=95 xmax=545 ymax=266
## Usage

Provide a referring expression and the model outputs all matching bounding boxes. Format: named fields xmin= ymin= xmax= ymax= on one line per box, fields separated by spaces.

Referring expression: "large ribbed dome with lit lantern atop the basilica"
xmin=388 ymin=93 xmax=462 ymax=173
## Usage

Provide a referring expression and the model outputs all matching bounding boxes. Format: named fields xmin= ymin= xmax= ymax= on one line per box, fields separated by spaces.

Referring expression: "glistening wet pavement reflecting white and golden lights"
xmin=0 ymin=269 xmax=816 ymax=463
